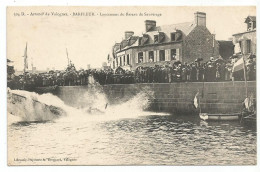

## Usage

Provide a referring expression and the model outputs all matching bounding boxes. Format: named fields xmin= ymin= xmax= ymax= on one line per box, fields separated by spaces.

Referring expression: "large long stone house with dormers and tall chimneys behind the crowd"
xmin=111 ymin=12 xmax=219 ymax=69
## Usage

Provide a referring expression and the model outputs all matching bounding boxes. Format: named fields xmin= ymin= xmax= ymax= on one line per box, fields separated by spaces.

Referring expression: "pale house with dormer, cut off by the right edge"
xmin=233 ymin=16 xmax=256 ymax=55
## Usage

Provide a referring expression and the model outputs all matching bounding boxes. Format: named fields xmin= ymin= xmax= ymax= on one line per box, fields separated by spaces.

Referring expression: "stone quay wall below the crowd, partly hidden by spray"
xmin=36 ymin=81 xmax=256 ymax=113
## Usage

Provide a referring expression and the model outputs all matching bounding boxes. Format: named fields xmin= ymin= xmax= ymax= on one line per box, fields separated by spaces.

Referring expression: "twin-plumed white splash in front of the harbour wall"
xmin=62 ymin=85 xmax=168 ymax=122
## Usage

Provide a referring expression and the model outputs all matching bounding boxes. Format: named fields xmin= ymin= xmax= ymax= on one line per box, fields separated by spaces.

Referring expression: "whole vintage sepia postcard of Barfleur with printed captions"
xmin=6 ymin=6 xmax=257 ymax=166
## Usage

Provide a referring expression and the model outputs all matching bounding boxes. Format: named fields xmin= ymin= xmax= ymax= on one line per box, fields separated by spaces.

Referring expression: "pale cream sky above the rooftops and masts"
xmin=7 ymin=6 xmax=256 ymax=70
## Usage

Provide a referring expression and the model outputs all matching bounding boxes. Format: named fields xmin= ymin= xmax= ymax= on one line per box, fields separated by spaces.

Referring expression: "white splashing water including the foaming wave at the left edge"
xmin=8 ymin=82 xmax=169 ymax=122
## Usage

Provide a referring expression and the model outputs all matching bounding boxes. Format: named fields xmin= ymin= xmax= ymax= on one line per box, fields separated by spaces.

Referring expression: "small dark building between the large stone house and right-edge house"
xmin=218 ymin=41 xmax=235 ymax=60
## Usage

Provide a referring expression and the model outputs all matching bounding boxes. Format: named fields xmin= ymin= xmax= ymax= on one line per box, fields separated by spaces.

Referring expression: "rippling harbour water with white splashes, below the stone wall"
xmin=7 ymin=83 xmax=257 ymax=165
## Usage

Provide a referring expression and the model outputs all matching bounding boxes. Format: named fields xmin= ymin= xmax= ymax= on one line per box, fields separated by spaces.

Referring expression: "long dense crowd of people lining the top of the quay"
xmin=8 ymin=58 xmax=256 ymax=89
